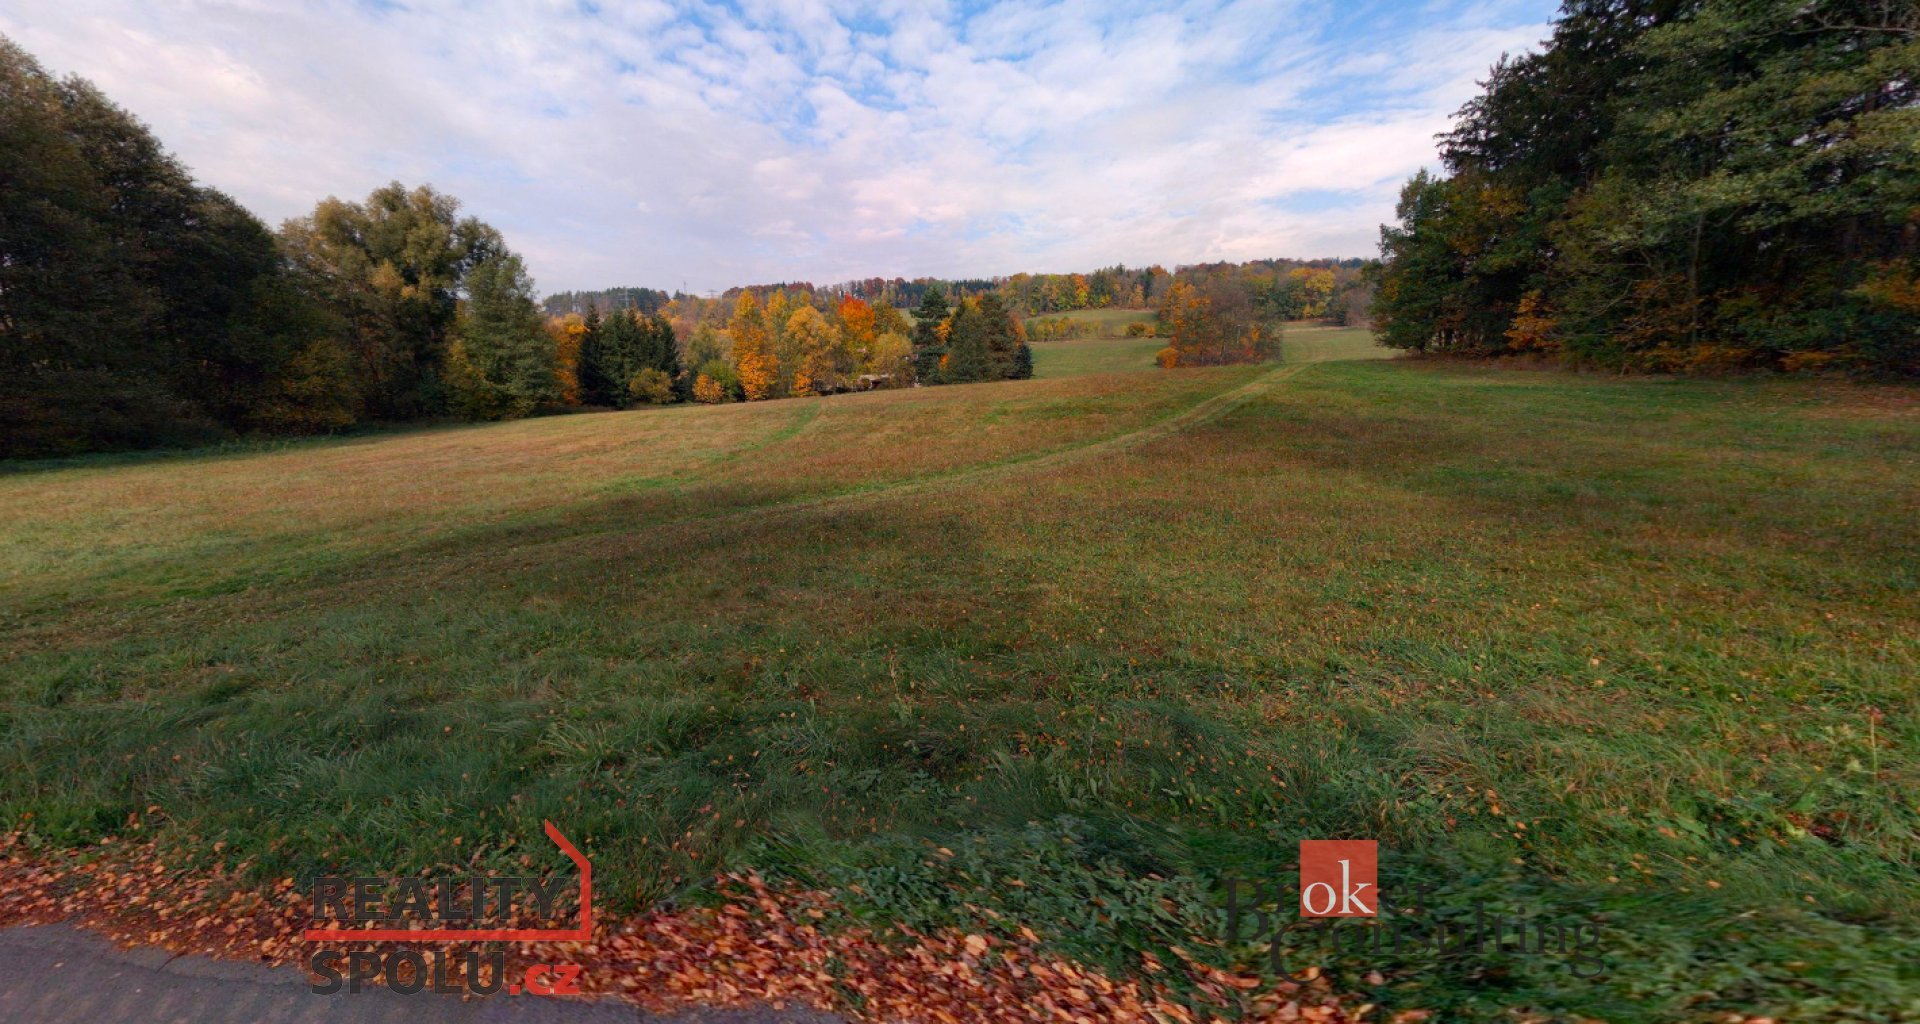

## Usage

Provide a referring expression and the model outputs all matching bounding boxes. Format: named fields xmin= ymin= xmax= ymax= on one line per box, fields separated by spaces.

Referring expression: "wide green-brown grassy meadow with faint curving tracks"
xmin=0 ymin=340 xmax=1920 ymax=1020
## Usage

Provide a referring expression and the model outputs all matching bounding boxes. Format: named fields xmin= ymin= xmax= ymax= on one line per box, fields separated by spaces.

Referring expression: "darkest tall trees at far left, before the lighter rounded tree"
xmin=0 ymin=38 xmax=355 ymax=455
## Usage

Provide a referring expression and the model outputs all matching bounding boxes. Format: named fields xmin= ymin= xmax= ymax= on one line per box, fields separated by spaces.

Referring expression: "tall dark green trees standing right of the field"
xmin=1375 ymin=0 xmax=1920 ymax=375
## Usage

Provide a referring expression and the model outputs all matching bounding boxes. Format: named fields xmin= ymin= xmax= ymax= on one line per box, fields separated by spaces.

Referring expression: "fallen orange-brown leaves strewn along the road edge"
xmin=0 ymin=840 xmax=1373 ymax=1024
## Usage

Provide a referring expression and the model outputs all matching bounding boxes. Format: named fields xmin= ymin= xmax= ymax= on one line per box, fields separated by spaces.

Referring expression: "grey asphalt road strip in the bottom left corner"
xmin=0 ymin=924 xmax=841 ymax=1024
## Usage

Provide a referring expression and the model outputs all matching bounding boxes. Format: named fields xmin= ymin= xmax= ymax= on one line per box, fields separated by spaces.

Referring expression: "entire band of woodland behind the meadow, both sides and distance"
xmin=0 ymin=0 xmax=1920 ymax=457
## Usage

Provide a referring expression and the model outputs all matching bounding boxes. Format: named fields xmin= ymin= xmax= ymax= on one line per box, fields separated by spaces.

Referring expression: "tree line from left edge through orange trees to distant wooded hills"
xmin=0 ymin=38 xmax=1371 ymax=457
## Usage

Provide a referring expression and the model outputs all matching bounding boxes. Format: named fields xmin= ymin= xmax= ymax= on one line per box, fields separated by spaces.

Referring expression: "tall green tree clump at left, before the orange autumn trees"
xmin=0 ymin=38 xmax=576 ymax=455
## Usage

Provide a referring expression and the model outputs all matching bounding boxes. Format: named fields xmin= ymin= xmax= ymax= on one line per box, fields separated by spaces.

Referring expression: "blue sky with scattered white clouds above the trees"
xmin=0 ymin=0 xmax=1555 ymax=292
